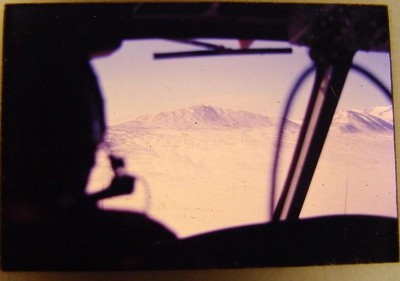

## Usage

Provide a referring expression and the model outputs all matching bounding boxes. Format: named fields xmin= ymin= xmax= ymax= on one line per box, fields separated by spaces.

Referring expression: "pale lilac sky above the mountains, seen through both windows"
xmin=92 ymin=39 xmax=390 ymax=124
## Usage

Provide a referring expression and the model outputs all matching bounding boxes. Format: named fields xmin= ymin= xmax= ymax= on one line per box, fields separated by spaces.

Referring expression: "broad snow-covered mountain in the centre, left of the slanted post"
xmin=114 ymin=105 xmax=298 ymax=129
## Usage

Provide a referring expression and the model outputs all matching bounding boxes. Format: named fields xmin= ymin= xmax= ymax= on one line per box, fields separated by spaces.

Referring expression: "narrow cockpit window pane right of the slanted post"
xmin=301 ymin=52 xmax=397 ymax=218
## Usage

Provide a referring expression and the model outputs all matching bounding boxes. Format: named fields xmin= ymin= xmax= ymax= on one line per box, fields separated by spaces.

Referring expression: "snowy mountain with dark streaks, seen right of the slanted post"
xmin=332 ymin=106 xmax=393 ymax=133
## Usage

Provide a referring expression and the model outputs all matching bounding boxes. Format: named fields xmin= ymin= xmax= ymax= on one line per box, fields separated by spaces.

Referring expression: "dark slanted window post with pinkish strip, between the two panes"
xmin=273 ymin=55 xmax=353 ymax=221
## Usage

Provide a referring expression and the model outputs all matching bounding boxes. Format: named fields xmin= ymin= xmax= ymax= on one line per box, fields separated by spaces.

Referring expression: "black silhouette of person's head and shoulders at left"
xmin=2 ymin=5 xmax=175 ymax=270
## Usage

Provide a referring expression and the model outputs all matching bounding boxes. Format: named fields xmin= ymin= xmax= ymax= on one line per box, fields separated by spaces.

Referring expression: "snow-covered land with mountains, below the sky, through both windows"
xmin=87 ymin=105 xmax=397 ymax=237
